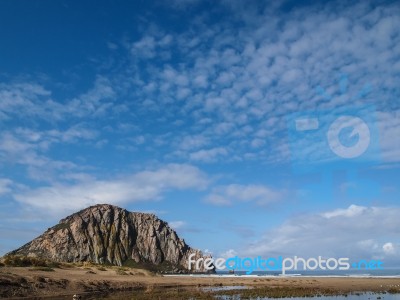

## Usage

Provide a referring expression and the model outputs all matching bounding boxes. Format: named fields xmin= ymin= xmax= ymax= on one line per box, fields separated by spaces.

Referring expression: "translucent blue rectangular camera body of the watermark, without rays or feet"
xmin=287 ymin=105 xmax=380 ymax=173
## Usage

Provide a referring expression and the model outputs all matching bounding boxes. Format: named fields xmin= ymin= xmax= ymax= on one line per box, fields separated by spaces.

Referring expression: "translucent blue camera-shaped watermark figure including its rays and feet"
xmin=287 ymin=77 xmax=380 ymax=199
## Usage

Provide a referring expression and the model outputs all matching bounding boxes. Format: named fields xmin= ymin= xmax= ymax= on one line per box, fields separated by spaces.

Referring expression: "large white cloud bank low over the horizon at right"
xmin=243 ymin=205 xmax=400 ymax=267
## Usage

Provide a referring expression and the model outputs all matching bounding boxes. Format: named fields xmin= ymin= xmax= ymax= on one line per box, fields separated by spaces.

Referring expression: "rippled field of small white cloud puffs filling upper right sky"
xmin=123 ymin=2 xmax=400 ymax=162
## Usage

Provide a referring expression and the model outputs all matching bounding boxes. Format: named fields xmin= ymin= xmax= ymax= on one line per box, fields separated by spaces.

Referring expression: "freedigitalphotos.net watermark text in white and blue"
xmin=188 ymin=254 xmax=383 ymax=275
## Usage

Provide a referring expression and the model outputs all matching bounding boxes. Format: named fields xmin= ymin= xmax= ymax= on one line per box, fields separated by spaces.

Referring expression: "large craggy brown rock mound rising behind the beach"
xmin=9 ymin=204 xmax=212 ymax=271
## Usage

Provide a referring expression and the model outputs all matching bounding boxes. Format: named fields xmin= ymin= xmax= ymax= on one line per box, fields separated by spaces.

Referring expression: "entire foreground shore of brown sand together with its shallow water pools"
xmin=0 ymin=265 xmax=400 ymax=300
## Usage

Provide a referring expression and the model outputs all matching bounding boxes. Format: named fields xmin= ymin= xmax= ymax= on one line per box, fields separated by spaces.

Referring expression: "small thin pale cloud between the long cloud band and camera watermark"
xmin=205 ymin=184 xmax=285 ymax=205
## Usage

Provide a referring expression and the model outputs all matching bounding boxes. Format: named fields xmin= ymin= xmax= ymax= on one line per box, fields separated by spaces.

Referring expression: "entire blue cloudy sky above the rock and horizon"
xmin=0 ymin=0 xmax=400 ymax=267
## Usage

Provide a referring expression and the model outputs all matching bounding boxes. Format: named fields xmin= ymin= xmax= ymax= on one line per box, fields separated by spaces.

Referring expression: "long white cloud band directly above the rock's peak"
xmin=14 ymin=164 xmax=208 ymax=214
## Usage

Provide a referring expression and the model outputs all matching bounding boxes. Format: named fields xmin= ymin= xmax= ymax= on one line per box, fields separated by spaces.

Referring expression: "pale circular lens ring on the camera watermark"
xmin=327 ymin=116 xmax=371 ymax=158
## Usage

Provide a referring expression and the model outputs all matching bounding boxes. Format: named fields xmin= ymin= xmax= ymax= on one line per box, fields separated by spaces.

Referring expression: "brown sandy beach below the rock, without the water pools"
xmin=0 ymin=267 xmax=400 ymax=299
